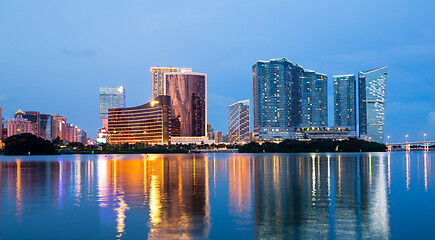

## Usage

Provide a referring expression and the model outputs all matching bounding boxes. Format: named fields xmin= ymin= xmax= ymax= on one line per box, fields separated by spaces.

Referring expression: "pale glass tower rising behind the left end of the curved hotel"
xmin=100 ymin=86 xmax=125 ymax=129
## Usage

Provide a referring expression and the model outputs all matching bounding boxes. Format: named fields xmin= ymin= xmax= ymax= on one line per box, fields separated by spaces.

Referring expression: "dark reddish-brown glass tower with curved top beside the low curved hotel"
xmin=165 ymin=71 xmax=207 ymax=137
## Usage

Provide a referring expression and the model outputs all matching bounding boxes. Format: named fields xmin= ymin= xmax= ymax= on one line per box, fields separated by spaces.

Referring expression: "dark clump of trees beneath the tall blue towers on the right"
xmin=238 ymin=138 xmax=386 ymax=153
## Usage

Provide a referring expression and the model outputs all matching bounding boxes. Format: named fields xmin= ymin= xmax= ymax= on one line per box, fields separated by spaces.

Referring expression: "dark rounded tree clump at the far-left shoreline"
xmin=4 ymin=133 xmax=56 ymax=155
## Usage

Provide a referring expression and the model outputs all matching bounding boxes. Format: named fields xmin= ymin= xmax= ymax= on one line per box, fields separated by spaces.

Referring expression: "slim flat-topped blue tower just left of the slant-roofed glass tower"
xmin=334 ymin=74 xmax=356 ymax=131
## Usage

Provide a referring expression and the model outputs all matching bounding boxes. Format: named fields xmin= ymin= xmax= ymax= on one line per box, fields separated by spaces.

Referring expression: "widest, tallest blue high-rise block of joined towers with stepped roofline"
xmin=252 ymin=58 xmax=328 ymax=140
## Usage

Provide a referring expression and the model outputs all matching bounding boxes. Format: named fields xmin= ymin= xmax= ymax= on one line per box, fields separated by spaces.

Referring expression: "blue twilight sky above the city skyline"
xmin=0 ymin=0 xmax=435 ymax=141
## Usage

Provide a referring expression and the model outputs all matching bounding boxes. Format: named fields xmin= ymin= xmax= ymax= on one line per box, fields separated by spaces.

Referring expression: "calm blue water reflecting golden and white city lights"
xmin=0 ymin=152 xmax=435 ymax=239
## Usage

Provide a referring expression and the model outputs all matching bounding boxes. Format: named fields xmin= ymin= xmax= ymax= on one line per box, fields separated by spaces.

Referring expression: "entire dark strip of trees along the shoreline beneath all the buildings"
xmin=4 ymin=133 xmax=386 ymax=155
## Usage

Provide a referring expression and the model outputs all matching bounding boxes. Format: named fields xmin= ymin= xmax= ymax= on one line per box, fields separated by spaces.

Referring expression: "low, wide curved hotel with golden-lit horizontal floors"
xmin=108 ymin=95 xmax=171 ymax=144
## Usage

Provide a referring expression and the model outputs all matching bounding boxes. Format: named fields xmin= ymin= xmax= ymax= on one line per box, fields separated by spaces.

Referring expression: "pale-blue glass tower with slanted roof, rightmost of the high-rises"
xmin=358 ymin=67 xmax=388 ymax=142
